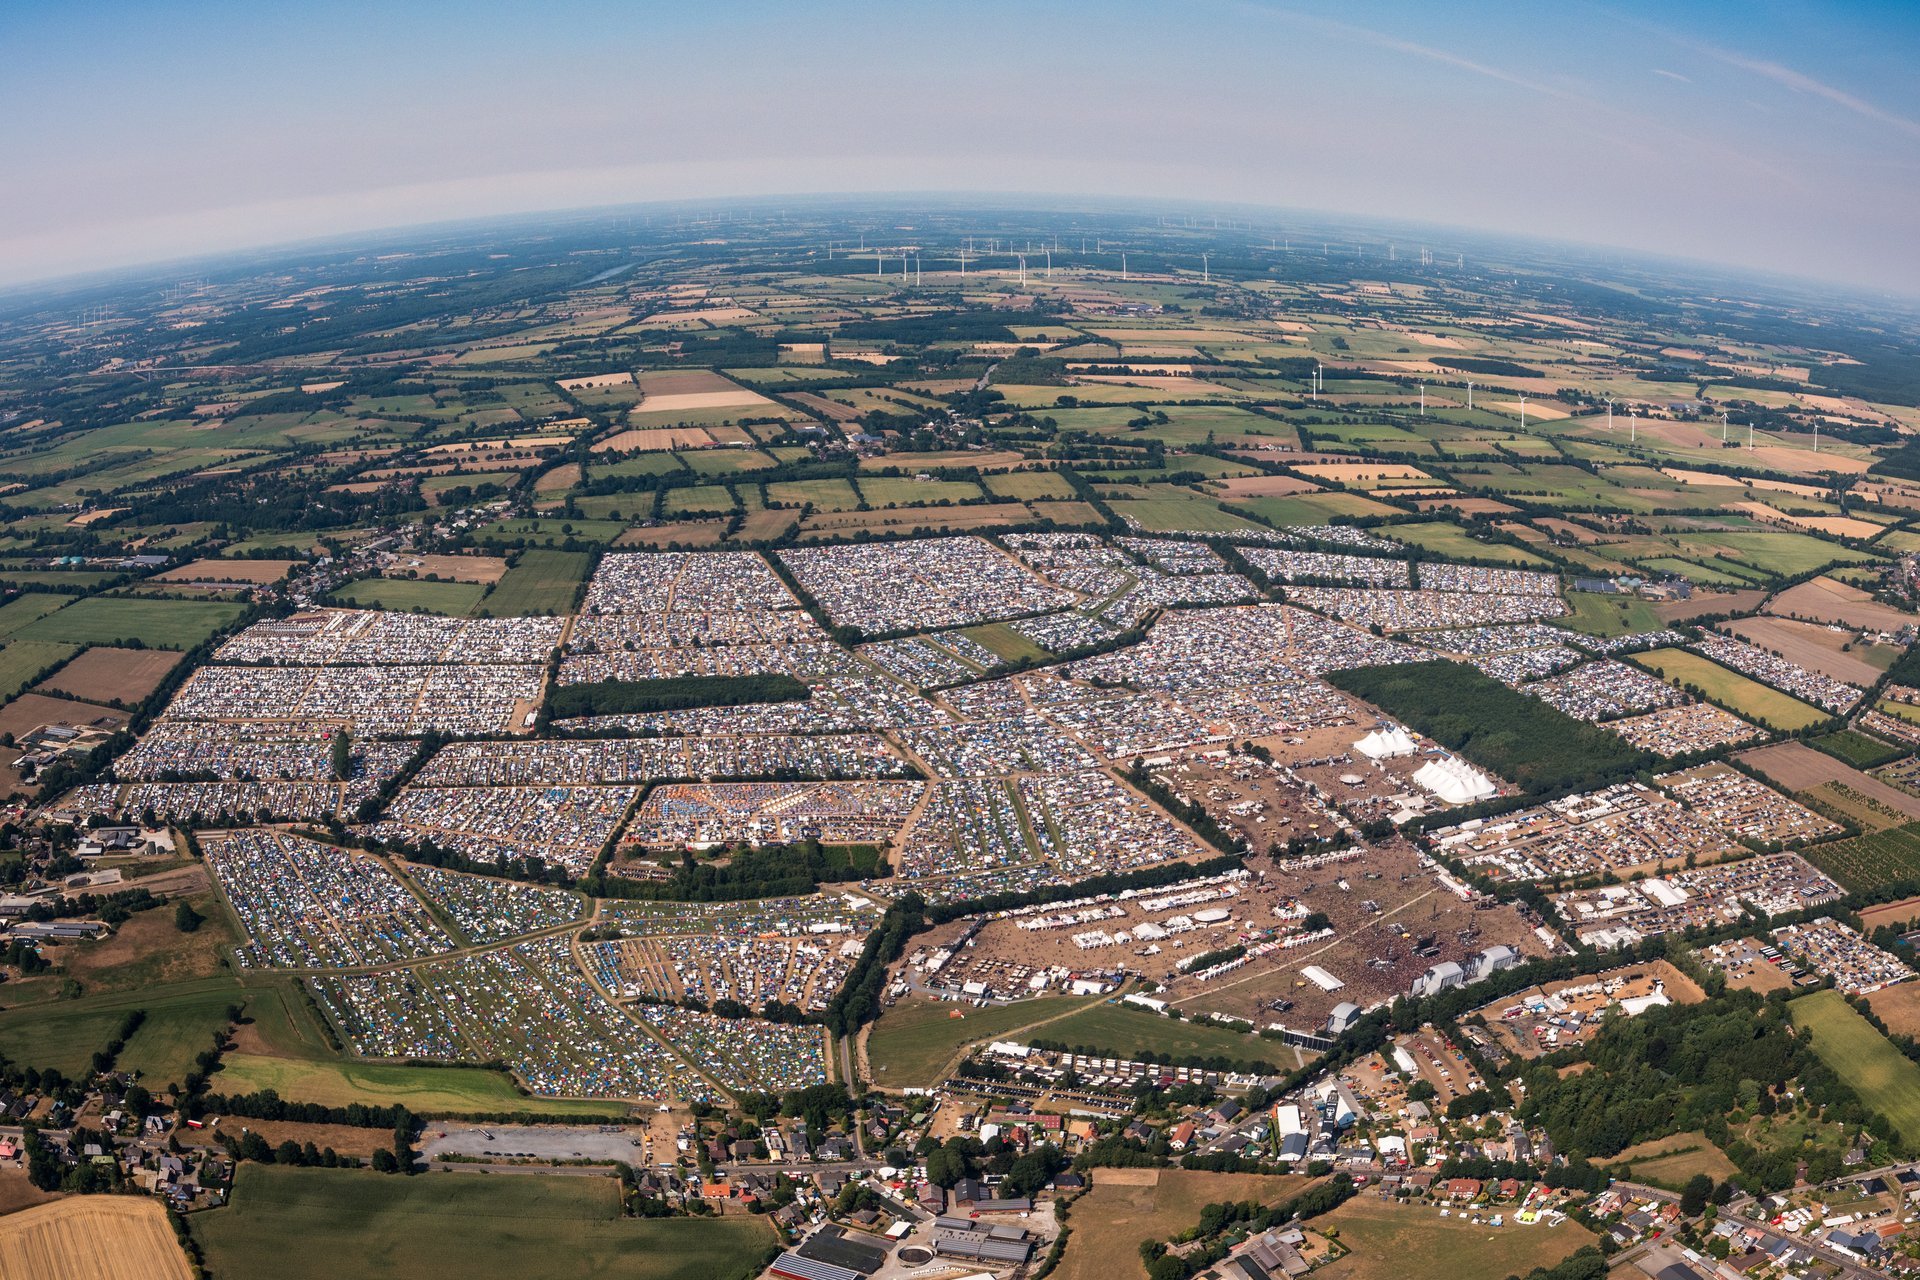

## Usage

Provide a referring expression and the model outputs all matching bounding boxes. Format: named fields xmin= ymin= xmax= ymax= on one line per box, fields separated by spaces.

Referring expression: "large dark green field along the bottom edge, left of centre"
xmin=192 ymin=1165 xmax=774 ymax=1280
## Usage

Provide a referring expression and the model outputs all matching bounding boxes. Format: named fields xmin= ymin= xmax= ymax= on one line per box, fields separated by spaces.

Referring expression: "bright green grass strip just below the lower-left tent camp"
xmin=213 ymin=1054 xmax=626 ymax=1115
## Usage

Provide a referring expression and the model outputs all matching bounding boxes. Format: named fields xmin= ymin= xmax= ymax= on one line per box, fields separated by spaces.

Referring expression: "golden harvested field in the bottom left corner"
xmin=0 ymin=1196 xmax=194 ymax=1280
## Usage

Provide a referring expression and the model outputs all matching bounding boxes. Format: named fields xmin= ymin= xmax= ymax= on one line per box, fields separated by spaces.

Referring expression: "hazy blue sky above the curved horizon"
xmin=0 ymin=0 xmax=1920 ymax=297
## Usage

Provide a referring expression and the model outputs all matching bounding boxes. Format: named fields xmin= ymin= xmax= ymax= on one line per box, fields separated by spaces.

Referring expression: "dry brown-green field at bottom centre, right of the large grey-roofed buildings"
xmin=1052 ymin=1169 xmax=1320 ymax=1280
